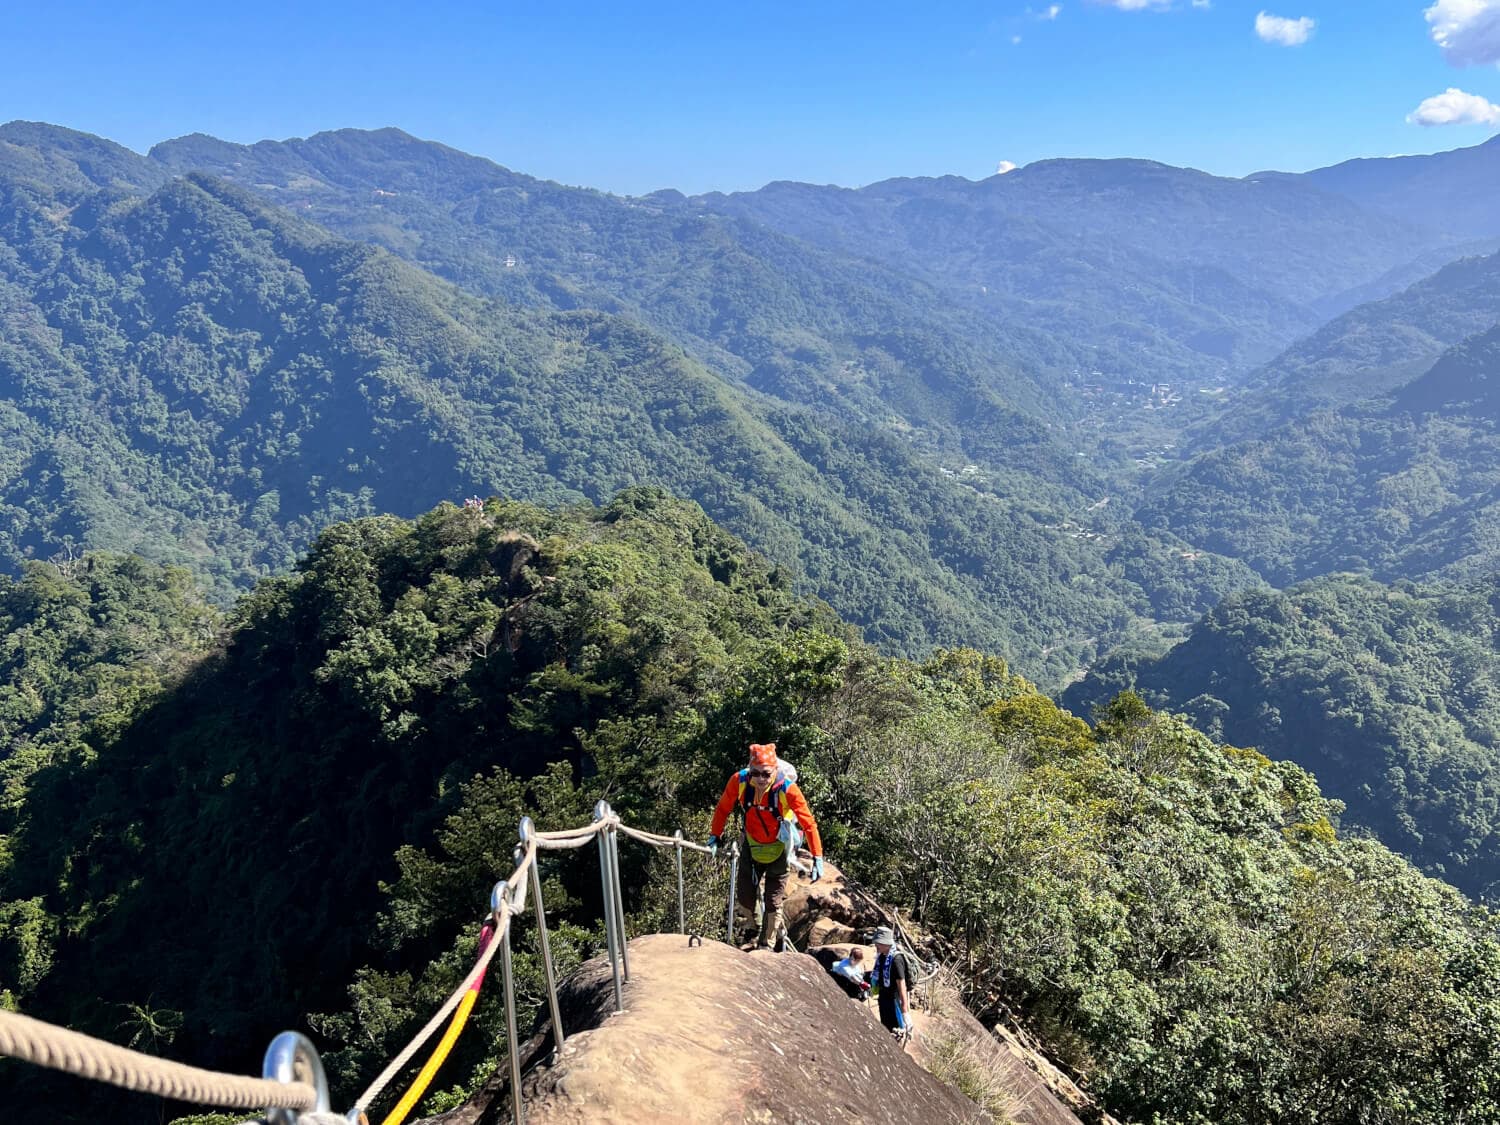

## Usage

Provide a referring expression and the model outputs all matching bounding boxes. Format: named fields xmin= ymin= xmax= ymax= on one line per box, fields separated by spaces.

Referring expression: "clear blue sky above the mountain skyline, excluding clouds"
xmin=0 ymin=0 xmax=1500 ymax=194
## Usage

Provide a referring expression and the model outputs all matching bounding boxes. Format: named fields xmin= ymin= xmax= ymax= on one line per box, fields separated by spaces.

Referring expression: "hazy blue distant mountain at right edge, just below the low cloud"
xmin=1256 ymin=137 xmax=1500 ymax=239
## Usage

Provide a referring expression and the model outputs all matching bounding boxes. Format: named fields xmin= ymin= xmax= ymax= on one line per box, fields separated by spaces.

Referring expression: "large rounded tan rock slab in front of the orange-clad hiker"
xmin=507 ymin=935 xmax=983 ymax=1125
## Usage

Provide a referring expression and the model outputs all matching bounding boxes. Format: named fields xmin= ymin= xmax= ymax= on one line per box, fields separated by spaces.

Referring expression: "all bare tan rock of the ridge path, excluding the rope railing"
xmin=425 ymin=867 xmax=1080 ymax=1125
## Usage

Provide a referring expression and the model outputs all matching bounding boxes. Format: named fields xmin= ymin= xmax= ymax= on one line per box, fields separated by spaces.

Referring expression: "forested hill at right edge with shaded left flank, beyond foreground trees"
xmin=1065 ymin=575 xmax=1500 ymax=900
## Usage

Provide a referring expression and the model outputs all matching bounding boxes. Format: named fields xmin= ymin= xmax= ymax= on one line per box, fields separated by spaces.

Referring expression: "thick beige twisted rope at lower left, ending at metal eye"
xmin=0 ymin=1011 xmax=318 ymax=1110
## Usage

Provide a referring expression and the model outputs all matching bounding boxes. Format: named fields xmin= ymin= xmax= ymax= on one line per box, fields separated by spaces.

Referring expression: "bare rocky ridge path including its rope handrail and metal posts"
xmin=0 ymin=801 xmax=1112 ymax=1125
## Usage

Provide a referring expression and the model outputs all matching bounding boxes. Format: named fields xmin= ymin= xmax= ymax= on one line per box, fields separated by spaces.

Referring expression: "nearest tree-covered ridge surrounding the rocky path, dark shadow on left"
xmin=0 ymin=501 xmax=1500 ymax=1125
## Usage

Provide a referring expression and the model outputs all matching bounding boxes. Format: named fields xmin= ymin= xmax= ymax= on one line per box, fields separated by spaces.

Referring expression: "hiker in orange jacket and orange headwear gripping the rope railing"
xmin=708 ymin=743 xmax=824 ymax=950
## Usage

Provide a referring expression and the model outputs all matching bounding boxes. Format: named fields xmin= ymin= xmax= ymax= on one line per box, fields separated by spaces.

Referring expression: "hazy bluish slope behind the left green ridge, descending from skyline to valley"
xmin=141 ymin=129 xmax=1085 ymax=480
